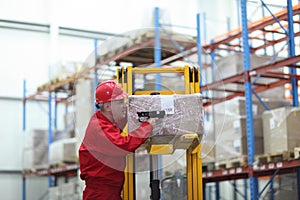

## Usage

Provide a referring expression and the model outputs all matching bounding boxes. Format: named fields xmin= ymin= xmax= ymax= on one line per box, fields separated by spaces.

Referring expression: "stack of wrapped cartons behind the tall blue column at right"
xmin=214 ymin=97 xmax=287 ymax=160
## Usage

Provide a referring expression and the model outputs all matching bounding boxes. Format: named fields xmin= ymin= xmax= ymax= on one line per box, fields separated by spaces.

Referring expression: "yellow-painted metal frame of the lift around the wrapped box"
xmin=117 ymin=66 xmax=203 ymax=200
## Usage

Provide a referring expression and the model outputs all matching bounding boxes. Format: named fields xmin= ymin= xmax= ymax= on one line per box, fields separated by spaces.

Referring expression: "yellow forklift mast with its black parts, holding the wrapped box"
xmin=116 ymin=65 xmax=203 ymax=200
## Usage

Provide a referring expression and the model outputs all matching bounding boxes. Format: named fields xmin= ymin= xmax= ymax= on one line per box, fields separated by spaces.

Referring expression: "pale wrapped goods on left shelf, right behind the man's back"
xmin=49 ymin=138 xmax=78 ymax=165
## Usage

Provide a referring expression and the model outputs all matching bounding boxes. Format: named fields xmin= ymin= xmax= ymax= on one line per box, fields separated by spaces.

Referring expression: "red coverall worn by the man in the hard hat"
xmin=79 ymin=111 xmax=152 ymax=200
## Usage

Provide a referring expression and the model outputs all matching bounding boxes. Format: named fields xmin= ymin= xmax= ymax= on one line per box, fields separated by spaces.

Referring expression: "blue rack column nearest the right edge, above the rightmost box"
xmin=287 ymin=0 xmax=299 ymax=107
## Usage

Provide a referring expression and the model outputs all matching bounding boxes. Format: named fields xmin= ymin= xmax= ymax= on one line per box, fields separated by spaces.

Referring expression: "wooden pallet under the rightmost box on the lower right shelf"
xmin=255 ymin=151 xmax=295 ymax=164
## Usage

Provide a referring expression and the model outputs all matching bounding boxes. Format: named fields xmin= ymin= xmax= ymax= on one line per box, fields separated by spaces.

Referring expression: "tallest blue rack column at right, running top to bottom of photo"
xmin=240 ymin=0 xmax=258 ymax=200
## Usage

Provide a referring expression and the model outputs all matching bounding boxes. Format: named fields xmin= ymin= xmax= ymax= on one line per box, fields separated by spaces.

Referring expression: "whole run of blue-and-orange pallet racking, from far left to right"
xmin=24 ymin=0 xmax=300 ymax=199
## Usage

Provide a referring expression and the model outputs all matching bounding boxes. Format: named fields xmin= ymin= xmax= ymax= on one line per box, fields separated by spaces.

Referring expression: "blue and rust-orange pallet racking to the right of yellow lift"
xmin=201 ymin=1 xmax=300 ymax=199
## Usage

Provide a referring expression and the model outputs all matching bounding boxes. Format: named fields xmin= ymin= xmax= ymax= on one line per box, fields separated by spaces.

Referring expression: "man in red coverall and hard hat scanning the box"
xmin=79 ymin=80 xmax=156 ymax=200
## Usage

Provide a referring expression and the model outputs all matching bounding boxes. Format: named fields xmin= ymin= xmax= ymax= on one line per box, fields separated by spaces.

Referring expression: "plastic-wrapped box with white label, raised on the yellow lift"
xmin=128 ymin=94 xmax=203 ymax=141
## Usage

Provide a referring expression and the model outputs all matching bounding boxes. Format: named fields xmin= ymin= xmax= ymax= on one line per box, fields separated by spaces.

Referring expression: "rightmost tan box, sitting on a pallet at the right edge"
xmin=263 ymin=107 xmax=300 ymax=153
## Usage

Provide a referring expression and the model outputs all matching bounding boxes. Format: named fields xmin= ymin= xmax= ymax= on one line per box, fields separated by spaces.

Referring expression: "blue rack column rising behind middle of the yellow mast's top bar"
xmin=154 ymin=7 xmax=161 ymax=90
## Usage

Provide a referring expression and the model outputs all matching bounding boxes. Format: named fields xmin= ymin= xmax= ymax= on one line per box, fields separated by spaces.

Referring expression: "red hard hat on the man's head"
xmin=95 ymin=80 xmax=128 ymax=103
